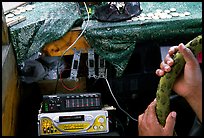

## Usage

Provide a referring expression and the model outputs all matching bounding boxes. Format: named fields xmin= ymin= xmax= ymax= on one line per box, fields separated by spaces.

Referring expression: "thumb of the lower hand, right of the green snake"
xmin=164 ymin=111 xmax=176 ymax=134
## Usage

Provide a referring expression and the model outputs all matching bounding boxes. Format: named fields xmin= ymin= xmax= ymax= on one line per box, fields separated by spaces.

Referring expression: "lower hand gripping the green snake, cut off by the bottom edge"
xmin=138 ymin=100 xmax=176 ymax=136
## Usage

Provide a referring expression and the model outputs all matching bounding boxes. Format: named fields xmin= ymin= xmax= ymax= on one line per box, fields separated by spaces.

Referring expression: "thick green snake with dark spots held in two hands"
xmin=156 ymin=35 xmax=202 ymax=126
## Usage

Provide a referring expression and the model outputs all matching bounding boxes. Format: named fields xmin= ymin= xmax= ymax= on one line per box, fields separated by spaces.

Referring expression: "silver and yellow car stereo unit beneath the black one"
xmin=38 ymin=110 xmax=109 ymax=136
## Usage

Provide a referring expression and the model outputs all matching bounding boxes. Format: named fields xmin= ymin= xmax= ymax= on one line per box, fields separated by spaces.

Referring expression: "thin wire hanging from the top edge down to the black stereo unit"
xmin=55 ymin=2 xmax=89 ymax=93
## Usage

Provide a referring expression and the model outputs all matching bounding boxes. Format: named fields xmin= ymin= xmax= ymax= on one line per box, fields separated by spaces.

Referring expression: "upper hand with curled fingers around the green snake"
xmin=156 ymin=43 xmax=202 ymax=98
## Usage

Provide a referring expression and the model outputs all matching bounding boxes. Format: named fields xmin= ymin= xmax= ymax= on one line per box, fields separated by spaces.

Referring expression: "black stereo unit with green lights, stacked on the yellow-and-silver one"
xmin=41 ymin=93 xmax=102 ymax=113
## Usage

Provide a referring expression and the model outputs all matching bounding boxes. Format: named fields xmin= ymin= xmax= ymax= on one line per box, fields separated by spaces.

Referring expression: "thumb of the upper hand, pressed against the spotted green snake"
xmin=178 ymin=43 xmax=196 ymax=64
